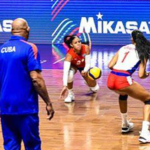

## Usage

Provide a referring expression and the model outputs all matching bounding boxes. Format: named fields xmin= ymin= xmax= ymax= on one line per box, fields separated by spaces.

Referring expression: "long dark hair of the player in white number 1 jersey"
xmin=132 ymin=30 xmax=150 ymax=62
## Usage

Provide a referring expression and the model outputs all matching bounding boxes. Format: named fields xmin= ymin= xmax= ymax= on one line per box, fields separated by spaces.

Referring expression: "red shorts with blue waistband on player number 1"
xmin=107 ymin=70 xmax=134 ymax=90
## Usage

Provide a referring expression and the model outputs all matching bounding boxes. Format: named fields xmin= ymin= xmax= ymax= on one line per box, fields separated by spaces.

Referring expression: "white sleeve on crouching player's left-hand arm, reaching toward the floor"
xmin=63 ymin=61 xmax=71 ymax=86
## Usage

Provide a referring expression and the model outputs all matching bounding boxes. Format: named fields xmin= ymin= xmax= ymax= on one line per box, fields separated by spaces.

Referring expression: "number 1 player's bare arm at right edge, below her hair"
xmin=139 ymin=60 xmax=149 ymax=79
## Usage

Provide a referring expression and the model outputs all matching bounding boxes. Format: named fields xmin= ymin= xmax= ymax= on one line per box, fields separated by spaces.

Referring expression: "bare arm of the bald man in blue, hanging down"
xmin=30 ymin=71 xmax=54 ymax=120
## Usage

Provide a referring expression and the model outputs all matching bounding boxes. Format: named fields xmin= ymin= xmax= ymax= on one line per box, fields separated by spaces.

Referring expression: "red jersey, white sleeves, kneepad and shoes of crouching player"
xmin=63 ymin=44 xmax=99 ymax=103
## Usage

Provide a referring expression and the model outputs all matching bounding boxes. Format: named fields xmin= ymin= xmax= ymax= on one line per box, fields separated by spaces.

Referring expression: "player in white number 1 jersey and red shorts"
xmin=107 ymin=30 xmax=150 ymax=143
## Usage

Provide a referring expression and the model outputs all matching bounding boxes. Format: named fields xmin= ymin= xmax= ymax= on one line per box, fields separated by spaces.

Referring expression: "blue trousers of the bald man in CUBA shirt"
xmin=1 ymin=114 xmax=41 ymax=150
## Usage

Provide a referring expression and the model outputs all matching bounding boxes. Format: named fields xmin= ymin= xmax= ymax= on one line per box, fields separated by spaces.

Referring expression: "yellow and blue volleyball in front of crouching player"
xmin=88 ymin=67 xmax=102 ymax=80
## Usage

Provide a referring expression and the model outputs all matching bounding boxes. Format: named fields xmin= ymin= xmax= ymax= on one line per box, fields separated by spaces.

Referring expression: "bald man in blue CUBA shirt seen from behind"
xmin=0 ymin=18 xmax=54 ymax=150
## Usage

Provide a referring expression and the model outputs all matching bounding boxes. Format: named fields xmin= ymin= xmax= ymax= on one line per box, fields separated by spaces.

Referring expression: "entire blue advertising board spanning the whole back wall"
xmin=0 ymin=0 xmax=150 ymax=45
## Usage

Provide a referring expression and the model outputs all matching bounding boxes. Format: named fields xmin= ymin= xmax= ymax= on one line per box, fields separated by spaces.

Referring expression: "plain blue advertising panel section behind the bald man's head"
xmin=0 ymin=0 xmax=51 ymax=44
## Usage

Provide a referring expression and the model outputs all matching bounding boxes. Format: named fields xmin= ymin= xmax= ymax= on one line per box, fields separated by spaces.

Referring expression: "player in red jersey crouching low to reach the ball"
xmin=60 ymin=36 xmax=99 ymax=102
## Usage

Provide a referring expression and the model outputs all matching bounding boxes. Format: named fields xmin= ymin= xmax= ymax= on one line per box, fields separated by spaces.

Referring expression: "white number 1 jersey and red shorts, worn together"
xmin=107 ymin=44 xmax=140 ymax=90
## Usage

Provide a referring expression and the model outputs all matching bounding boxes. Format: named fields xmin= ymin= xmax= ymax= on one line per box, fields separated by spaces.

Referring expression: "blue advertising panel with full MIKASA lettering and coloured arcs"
xmin=51 ymin=0 xmax=150 ymax=45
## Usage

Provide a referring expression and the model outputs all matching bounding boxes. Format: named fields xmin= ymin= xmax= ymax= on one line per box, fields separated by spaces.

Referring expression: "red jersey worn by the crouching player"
xmin=67 ymin=44 xmax=86 ymax=72
